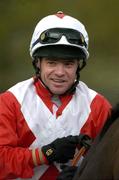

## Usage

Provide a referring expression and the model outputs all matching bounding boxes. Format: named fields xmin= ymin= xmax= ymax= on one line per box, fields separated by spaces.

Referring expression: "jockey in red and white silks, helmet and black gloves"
xmin=0 ymin=12 xmax=111 ymax=180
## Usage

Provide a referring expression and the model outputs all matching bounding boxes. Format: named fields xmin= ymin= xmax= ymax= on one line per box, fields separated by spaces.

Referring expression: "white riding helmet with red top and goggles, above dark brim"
xmin=30 ymin=11 xmax=89 ymax=59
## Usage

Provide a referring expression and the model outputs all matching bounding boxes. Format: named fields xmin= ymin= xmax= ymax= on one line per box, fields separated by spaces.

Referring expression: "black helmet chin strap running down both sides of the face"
xmin=32 ymin=59 xmax=86 ymax=95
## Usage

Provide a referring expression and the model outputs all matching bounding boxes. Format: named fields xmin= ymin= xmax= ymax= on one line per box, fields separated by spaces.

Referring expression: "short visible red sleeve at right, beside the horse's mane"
xmin=81 ymin=94 xmax=112 ymax=139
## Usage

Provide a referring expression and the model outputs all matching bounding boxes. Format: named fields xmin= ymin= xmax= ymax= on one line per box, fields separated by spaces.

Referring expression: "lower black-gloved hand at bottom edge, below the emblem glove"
xmin=56 ymin=165 xmax=77 ymax=180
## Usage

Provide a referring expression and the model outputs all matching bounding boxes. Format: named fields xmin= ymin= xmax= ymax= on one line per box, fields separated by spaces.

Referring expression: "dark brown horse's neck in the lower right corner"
xmin=73 ymin=104 xmax=119 ymax=180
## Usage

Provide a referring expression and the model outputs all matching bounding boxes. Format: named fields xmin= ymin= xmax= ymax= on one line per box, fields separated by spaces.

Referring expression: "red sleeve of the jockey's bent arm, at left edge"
xmin=0 ymin=92 xmax=34 ymax=179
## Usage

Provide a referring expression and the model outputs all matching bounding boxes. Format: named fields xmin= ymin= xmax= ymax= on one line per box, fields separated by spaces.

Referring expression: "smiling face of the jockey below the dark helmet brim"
xmin=37 ymin=58 xmax=79 ymax=95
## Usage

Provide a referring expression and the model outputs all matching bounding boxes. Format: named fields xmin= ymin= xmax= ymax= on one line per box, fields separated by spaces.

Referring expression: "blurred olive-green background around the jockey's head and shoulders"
xmin=0 ymin=0 xmax=119 ymax=104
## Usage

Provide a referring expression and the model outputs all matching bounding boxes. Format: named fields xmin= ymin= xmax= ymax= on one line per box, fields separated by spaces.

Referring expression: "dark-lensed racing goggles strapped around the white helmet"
xmin=32 ymin=28 xmax=87 ymax=48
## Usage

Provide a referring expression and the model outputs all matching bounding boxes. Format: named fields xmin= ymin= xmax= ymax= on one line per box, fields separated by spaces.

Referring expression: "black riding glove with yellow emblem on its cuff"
xmin=42 ymin=136 xmax=78 ymax=163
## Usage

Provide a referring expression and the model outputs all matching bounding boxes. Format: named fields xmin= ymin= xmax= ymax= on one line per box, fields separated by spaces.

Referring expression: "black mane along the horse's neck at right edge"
xmin=100 ymin=103 xmax=119 ymax=139
